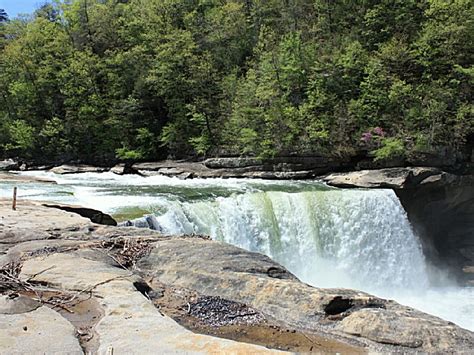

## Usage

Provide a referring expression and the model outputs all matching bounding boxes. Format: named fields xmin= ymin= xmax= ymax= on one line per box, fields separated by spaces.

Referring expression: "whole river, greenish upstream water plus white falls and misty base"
xmin=0 ymin=172 xmax=474 ymax=330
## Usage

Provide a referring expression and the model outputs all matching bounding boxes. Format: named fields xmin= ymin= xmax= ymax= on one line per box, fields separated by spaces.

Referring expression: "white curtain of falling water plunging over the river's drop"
xmin=149 ymin=190 xmax=428 ymax=292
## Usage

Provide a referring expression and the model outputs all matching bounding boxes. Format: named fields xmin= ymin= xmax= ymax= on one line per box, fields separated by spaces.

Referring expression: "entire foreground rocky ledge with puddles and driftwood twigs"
xmin=0 ymin=201 xmax=474 ymax=354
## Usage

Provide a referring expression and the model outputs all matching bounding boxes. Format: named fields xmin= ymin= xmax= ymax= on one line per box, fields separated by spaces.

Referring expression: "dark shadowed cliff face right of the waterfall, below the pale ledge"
xmin=397 ymin=177 xmax=474 ymax=286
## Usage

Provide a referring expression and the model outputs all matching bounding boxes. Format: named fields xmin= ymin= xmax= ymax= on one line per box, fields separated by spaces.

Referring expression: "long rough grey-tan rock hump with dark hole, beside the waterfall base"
xmin=138 ymin=239 xmax=474 ymax=352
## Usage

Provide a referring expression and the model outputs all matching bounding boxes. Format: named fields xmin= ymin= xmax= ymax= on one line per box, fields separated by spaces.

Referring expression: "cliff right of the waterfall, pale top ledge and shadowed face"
xmin=323 ymin=167 xmax=474 ymax=286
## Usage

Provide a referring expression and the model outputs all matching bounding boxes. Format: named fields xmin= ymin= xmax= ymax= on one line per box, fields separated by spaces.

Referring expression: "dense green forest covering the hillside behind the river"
xmin=0 ymin=0 xmax=474 ymax=161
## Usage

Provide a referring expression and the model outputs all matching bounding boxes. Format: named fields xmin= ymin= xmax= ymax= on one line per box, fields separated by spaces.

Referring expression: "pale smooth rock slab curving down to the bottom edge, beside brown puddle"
xmin=18 ymin=253 xmax=282 ymax=354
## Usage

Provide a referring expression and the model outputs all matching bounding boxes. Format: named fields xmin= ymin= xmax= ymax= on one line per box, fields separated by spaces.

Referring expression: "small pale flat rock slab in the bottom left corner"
xmin=0 ymin=306 xmax=83 ymax=355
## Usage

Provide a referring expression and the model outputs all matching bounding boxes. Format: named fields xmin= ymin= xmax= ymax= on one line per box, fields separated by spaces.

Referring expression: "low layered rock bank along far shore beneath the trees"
xmin=0 ymin=152 xmax=474 ymax=179
